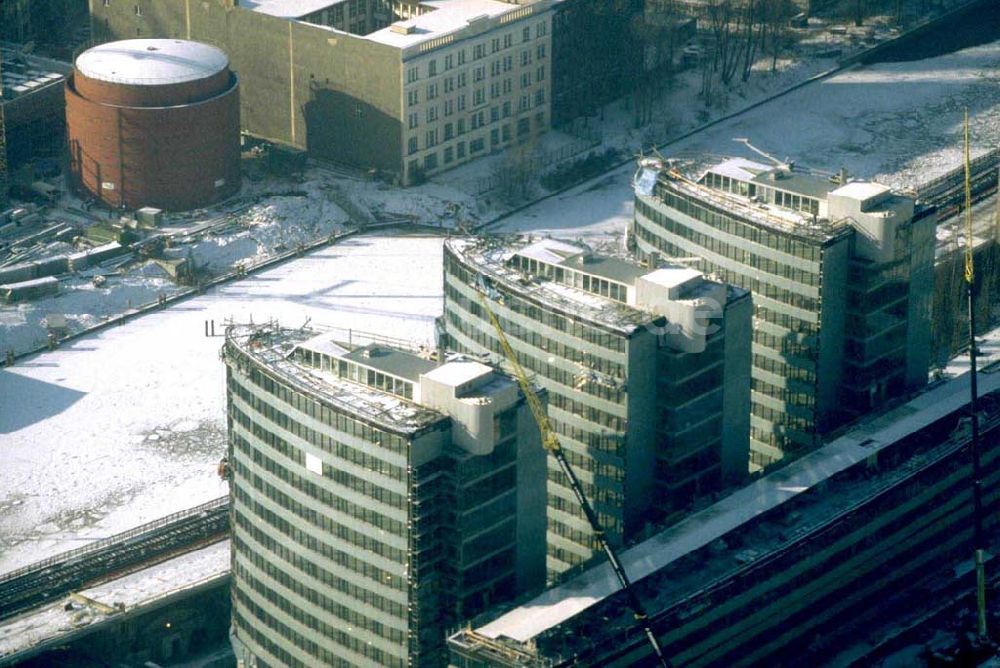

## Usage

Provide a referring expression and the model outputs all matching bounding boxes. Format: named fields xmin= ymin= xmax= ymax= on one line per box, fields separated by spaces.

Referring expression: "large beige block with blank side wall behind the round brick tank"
xmin=91 ymin=0 xmax=552 ymax=184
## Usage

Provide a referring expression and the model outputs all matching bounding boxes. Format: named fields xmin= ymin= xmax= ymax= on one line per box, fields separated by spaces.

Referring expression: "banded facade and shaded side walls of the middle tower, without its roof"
xmin=443 ymin=243 xmax=750 ymax=580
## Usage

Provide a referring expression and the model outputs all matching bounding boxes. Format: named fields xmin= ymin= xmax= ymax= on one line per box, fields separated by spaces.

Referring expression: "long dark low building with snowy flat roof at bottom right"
xmin=449 ymin=374 xmax=1000 ymax=668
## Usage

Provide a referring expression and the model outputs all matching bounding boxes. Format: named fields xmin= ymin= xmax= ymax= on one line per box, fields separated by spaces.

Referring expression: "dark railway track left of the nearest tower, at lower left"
xmin=0 ymin=497 xmax=229 ymax=619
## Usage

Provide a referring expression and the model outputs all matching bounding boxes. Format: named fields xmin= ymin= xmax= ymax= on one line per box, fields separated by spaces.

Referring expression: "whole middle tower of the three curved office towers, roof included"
xmin=443 ymin=238 xmax=751 ymax=578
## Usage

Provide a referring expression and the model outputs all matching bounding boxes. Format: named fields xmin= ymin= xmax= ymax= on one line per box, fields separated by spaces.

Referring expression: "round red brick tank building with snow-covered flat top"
xmin=66 ymin=39 xmax=240 ymax=211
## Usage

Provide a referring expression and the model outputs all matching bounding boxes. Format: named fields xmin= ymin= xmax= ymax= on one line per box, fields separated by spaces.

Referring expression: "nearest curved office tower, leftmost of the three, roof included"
xmin=224 ymin=325 xmax=545 ymax=668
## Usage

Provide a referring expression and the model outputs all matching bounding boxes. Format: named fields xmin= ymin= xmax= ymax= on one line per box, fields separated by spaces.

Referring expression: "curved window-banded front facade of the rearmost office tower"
xmin=633 ymin=188 xmax=850 ymax=468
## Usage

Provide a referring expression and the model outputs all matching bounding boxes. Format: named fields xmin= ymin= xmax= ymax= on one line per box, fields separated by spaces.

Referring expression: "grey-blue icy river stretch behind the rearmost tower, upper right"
xmin=669 ymin=42 xmax=1000 ymax=187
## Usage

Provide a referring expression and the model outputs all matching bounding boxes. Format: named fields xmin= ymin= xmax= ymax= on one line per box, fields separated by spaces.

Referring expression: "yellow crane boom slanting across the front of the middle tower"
xmin=479 ymin=276 xmax=670 ymax=668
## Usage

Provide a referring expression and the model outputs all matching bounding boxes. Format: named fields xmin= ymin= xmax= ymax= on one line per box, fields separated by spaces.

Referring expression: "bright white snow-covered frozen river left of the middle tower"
xmin=0 ymin=237 xmax=442 ymax=572
